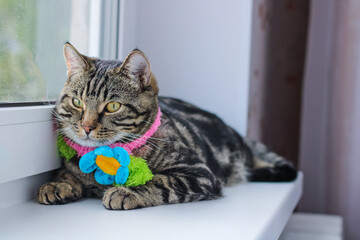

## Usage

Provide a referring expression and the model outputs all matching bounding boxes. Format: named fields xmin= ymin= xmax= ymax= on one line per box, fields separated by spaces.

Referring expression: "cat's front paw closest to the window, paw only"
xmin=37 ymin=182 xmax=78 ymax=205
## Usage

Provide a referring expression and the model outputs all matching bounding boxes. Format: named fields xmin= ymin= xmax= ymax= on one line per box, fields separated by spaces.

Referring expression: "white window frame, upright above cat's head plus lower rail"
xmin=0 ymin=0 xmax=120 ymax=186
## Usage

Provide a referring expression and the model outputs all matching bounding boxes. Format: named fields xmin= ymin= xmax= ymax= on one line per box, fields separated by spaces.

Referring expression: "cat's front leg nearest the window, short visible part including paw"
xmin=37 ymin=169 xmax=84 ymax=205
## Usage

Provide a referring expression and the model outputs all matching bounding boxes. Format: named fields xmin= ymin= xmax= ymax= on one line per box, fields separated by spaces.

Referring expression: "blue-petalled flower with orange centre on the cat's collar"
xmin=79 ymin=146 xmax=130 ymax=185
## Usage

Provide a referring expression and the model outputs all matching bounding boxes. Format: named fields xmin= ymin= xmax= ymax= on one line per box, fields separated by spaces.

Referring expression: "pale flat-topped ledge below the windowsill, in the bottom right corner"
xmin=280 ymin=213 xmax=343 ymax=240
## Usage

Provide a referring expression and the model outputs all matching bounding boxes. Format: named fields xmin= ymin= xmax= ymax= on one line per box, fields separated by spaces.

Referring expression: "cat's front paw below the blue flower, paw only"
xmin=103 ymin=187 xmax=145 ymax=210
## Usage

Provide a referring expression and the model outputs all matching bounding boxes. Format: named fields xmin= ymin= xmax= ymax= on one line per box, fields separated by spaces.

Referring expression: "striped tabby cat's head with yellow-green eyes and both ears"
xmin=55 ymin=43 xmax=158 ymax=147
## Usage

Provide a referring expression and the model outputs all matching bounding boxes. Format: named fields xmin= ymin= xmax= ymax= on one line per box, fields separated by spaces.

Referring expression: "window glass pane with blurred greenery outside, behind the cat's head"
xmin=0 ymin=0 xmax=98 ymax=103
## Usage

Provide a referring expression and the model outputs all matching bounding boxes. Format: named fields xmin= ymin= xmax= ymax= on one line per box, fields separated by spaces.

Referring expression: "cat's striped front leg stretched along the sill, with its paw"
xmin=103 ymin=174 xmax=222 ymax=210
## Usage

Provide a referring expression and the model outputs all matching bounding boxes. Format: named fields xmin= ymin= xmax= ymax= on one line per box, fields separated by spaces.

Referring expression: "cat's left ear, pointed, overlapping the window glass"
xmin=63 ymin=42 xmax=89 ymax=78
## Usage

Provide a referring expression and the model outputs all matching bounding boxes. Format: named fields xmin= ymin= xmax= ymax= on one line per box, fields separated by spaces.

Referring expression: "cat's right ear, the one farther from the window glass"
xmin=121 ymin=49 xmax=151 ymax=87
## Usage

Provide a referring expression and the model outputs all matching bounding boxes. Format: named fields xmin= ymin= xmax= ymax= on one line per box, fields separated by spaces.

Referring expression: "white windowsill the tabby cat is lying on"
xmin=0 ymin=174 xmax=302 ymax=240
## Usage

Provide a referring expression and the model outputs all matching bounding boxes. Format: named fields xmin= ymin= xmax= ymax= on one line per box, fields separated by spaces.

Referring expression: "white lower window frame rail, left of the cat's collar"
xmin=0 ymin=106 xmax=61 ymax=184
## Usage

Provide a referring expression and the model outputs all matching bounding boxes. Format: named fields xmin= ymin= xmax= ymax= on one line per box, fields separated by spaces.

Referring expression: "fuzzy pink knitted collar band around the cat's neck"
xmin=64 ymin=108 xmax=162 ymax=156
